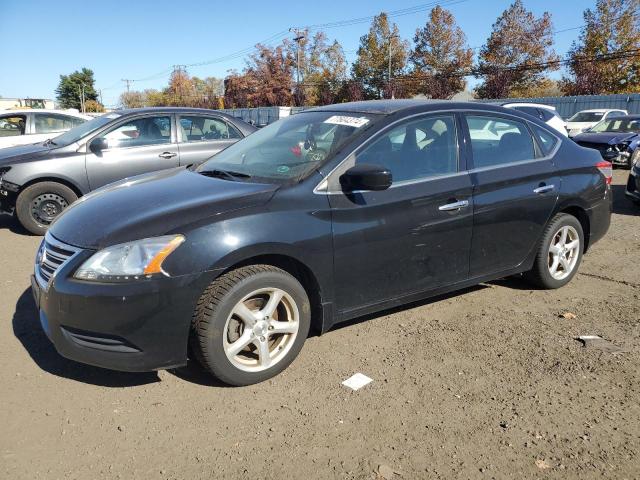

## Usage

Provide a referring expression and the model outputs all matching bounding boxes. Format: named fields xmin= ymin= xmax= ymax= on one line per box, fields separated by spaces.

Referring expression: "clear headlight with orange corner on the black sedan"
xmin=74 ymin=235 xmax=184 ymax=282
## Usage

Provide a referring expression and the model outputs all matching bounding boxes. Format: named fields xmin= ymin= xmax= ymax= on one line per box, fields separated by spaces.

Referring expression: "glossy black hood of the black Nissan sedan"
xmin=49 ymin=168 xmax=278 ymax=249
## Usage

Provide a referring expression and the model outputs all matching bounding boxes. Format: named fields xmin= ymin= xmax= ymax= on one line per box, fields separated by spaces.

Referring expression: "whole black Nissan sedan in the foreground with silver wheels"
xmin=32 ymin=101 xmax=612 ymax=385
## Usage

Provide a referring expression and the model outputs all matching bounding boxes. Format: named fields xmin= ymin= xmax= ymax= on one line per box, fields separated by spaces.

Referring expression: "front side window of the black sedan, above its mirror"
xmin=355 ymin=115 xmax=458 ymax=183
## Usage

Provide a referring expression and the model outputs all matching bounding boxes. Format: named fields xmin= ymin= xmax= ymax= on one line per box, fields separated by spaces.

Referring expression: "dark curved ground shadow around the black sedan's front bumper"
xmin=13 ymin=289 xmax=160 ymax=388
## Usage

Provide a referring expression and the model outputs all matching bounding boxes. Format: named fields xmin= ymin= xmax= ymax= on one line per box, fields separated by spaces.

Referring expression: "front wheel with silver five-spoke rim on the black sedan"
xmin=190 ymin=265 xmax=311 ymax=386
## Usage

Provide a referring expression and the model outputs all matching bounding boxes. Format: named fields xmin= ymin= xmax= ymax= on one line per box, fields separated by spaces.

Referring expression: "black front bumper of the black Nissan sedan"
xmin=31 ymin=244 xmax=208 ymax=372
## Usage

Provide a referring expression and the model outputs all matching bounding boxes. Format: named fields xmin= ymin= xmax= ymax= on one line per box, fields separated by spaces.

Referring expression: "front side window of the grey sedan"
xmin=102 ymin=116 xmax=171 ymax=149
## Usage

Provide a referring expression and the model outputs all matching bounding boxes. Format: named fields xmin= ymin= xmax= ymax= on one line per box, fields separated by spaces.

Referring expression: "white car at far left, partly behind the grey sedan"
xmin=0 ymin=109 xmax=91 ymax=148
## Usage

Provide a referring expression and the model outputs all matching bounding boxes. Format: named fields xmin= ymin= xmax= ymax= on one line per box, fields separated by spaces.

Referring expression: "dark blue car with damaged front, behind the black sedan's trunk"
xmin=573 ymin=115 xmax=640 ymax=168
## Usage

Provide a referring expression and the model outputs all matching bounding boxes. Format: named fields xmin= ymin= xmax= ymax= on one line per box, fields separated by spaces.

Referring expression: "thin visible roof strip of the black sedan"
xmin=300 ymin=99 xmax=524 ymax=115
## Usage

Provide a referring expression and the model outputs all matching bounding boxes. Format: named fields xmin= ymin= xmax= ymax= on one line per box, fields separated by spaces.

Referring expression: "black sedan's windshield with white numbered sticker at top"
xmin=197 ymin=112 xmax=379 ymax=183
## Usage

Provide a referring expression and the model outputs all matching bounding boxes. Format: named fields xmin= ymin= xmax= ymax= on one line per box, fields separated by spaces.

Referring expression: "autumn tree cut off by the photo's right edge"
xmin=561 ymin=0 xmax=640 ymax=95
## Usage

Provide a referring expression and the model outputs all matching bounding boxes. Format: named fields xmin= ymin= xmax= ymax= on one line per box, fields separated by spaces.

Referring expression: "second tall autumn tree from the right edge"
xmin=476 ymin=0 xmax=558 ymax=98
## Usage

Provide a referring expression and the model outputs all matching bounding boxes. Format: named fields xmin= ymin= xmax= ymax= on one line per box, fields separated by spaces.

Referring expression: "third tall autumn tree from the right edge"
xmin=410 ymin=6 xmax=473 ymax=98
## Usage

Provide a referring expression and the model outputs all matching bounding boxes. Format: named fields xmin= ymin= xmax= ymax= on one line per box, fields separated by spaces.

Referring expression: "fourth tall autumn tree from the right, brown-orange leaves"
xmin=352 ymin=12 xmax=409 ymax=98
